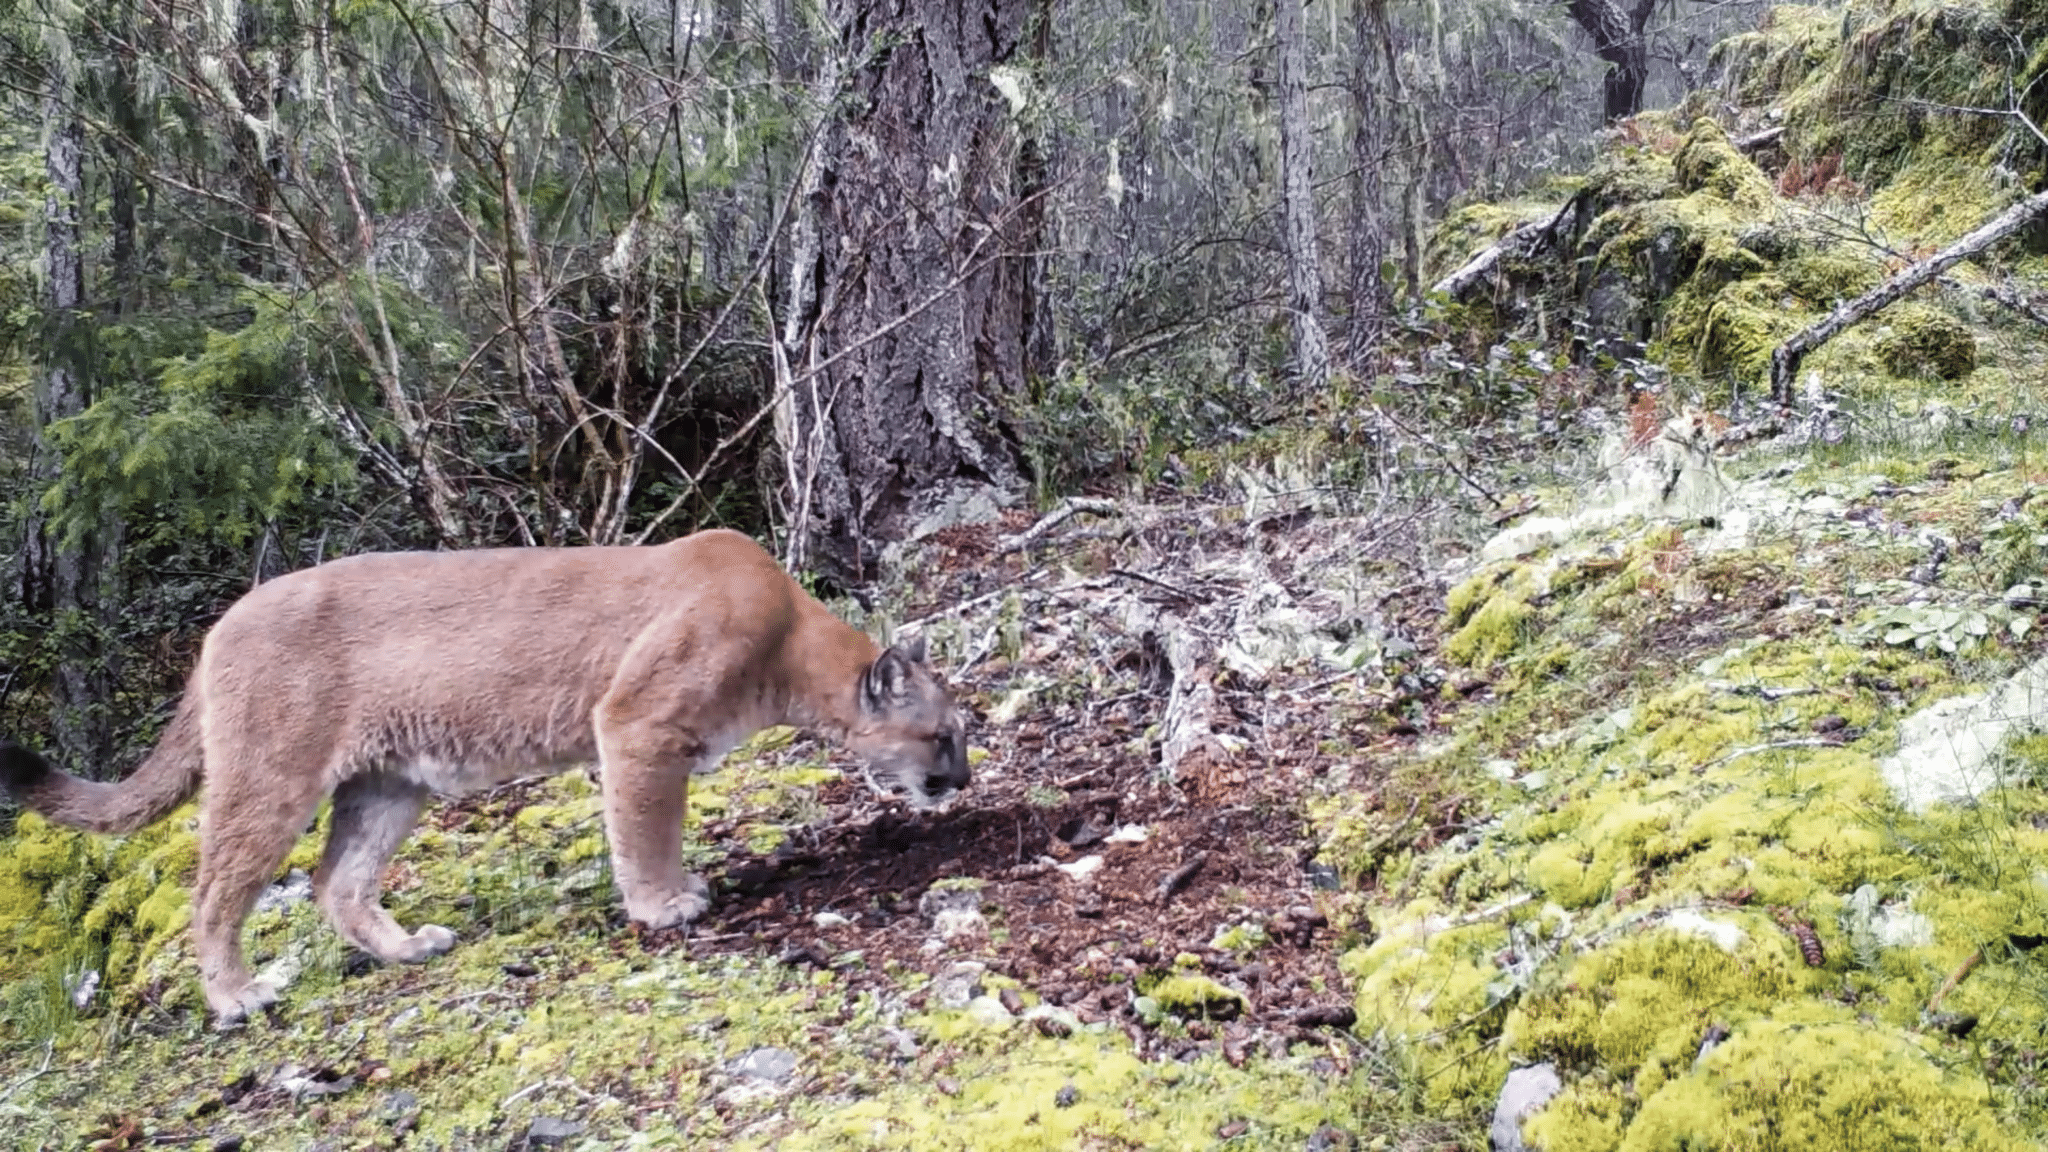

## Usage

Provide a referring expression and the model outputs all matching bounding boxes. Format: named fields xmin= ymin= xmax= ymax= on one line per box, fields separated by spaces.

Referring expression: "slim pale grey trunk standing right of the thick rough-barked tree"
xmin=1274 ymin=0 xmax=1329 ymax=394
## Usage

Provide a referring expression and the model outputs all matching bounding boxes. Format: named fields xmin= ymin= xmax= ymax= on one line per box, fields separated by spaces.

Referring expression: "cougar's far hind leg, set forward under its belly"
xmin=313 ymin=773 xmax=455 ymax=963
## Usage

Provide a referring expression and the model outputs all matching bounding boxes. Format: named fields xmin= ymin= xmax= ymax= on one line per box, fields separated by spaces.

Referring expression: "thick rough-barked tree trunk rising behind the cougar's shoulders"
xmin=780 ymin=0 xmax=1047 ymax=582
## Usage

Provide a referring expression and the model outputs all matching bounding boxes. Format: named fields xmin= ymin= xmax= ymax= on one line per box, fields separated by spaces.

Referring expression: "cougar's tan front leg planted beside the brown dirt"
xmin=596 ymin=701 xmax=711 ymax=929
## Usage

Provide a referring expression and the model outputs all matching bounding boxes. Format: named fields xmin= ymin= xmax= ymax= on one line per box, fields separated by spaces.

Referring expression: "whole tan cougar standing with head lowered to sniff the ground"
xmin=0 ymin=531 xmax=967 ymax=1023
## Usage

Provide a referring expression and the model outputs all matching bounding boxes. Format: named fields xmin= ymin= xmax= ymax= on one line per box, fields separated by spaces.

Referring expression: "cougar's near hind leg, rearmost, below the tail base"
xmin=193 ymin=742 xmax=322 ymax=1025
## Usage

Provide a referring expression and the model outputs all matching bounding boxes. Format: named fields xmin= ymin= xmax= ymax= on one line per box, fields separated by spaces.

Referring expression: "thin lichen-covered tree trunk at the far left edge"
xmin=23 ymin=53 xmax=121 ymax=777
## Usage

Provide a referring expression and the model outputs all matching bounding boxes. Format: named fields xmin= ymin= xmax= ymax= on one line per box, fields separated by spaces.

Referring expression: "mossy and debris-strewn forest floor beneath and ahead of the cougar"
xmin=0 ymin=440 xmax=1485 ymax=1150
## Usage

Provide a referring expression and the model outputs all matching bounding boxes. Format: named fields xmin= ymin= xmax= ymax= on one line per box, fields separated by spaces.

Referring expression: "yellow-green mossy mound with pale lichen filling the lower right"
xmin=1327 ymin=461 xmax=2048 ymax=1152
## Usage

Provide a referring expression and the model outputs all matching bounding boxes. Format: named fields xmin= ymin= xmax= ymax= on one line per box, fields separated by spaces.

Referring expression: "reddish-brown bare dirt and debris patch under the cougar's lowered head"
xmin=616 ymin=506 xmax=1458 ymax=1060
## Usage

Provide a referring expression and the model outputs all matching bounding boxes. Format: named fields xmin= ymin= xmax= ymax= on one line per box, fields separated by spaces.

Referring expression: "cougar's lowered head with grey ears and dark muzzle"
xmin=848 ymin=635 xmax=969 ymax=808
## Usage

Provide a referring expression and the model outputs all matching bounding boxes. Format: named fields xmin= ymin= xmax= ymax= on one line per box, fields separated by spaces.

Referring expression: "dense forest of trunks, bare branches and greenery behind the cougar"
xmin=0 ymin=0 xmax=1763 ymax=777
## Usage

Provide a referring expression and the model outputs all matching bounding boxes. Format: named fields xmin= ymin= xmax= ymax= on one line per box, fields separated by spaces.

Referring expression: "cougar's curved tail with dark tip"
xmin=0 ymin=674 xmax=203 ymax=832
